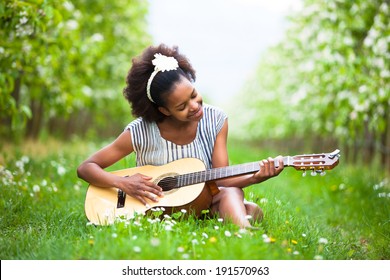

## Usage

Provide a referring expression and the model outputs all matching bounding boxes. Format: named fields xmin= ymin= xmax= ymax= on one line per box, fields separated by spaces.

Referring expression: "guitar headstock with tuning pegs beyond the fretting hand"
xmin=289 ymin=149 xmax=340 ymax=176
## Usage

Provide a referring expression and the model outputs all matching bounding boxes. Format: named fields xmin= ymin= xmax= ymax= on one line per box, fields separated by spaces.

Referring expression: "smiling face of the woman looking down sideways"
xmin=159 ymin=78 xmax=203 ymax=122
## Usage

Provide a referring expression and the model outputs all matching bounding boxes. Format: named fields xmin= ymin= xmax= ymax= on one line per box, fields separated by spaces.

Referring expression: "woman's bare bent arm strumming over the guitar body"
xmin=77 ymin=130 xmax=162 ymax=204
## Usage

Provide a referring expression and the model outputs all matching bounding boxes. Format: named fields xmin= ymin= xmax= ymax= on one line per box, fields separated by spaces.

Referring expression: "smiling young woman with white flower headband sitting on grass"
xmin=77 ymin=44 xmax=284 ymax=228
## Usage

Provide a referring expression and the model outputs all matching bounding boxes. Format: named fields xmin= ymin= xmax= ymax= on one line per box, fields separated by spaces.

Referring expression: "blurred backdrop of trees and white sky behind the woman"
xmin=0 ymin=0 xmax=390 ymax=170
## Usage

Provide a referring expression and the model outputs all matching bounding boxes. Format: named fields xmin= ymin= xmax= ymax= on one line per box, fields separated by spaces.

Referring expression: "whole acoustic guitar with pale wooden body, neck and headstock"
xmin=85 ymin=150 xmax=340 ymax=225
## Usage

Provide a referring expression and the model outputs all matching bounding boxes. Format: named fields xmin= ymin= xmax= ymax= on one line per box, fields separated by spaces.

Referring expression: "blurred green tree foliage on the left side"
xmin=0 ymin=0 xmax=150 ymax=139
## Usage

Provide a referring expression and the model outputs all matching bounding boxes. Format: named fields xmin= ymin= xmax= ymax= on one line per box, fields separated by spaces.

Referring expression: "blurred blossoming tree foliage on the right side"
xmin=233 ymin=0 xmax=390 ymax=145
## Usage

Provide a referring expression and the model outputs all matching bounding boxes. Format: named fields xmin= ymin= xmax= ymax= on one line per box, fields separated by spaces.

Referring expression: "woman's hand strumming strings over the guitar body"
xmin=115 ymin=173 xmax=164 ymax=206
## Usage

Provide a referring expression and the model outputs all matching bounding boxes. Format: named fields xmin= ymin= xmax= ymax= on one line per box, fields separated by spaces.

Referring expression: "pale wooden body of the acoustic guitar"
xmin=85 ymin=158 xmax=216 ymax=225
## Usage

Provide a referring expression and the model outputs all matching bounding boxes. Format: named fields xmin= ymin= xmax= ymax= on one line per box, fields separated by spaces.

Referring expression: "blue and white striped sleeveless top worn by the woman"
xmin=126 ymin=104 xmax=227 ymax=169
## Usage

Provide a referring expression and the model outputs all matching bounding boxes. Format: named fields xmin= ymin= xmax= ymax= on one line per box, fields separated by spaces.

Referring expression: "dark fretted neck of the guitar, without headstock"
xmin=176 ymin=156 xmax=291 ymax=187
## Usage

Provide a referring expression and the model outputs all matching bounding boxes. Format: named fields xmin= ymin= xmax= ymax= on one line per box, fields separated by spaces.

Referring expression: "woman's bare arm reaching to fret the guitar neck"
xmin=212 ymin=120 xmax=284 ymax=188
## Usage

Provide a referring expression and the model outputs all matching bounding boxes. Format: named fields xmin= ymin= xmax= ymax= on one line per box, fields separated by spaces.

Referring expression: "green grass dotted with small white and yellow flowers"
xmin=0 ymin=139 xmax=390 ymax=260
